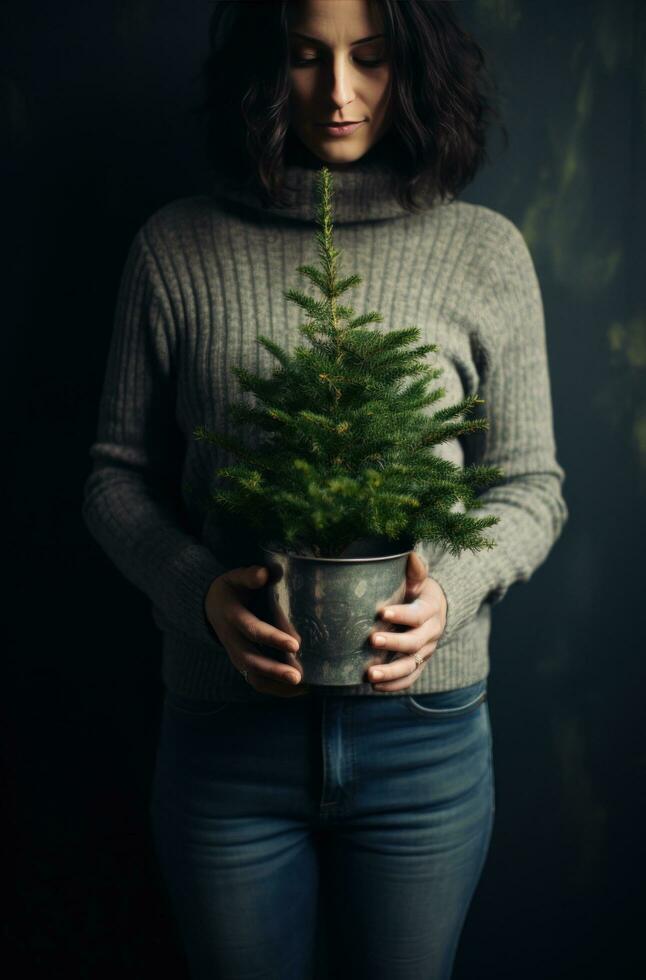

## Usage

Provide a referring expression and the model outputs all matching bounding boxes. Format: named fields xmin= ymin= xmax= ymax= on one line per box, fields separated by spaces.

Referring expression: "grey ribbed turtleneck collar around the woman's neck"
xmin=213 ymin=159 xmax=442 ymax=224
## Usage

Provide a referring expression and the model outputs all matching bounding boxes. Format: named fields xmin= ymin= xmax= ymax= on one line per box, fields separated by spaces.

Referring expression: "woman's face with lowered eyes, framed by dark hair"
xmin=288 ymin=0 xmax=391 ymax=169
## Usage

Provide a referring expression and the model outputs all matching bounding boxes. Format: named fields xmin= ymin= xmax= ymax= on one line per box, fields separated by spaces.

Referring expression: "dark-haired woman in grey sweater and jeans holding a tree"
xmin=84 ymin=0 xmax=568 ymax=980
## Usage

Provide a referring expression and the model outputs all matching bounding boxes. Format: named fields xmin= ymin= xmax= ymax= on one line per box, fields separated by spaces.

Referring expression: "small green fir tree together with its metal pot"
xmin=193 ymin=166 xmax=504 ymax=685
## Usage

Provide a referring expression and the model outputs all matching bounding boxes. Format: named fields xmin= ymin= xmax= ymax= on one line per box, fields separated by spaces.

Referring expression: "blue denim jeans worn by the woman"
xmin=150 ymin=680 xmax=494 ymax=980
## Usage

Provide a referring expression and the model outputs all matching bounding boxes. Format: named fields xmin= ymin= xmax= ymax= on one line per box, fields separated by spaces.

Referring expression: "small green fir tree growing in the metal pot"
xmin=193 ymin=166 xmax=504 ymax=557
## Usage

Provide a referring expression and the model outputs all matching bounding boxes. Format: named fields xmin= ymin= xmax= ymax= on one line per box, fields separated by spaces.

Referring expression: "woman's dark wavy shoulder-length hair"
xmin=200 ymin=0 xmax=508 ymax=212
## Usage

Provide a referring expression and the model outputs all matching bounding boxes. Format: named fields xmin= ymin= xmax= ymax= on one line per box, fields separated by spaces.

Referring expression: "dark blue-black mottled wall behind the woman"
xmin=0 ymin=0 xmax=646 ymax=980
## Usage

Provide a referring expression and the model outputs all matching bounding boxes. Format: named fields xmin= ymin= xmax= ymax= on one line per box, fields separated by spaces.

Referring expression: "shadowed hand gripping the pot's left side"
xmin=204 ymin=565 xmax=309 ymax=698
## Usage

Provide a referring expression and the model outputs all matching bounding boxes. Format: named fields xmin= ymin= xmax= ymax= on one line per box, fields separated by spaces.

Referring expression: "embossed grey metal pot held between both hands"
xmin=253 ymin=538 xmax=411 ymax=686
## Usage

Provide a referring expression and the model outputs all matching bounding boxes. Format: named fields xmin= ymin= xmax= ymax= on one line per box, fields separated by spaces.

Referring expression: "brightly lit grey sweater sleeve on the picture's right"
xmin=426 ymin=221 xmax=568 ymax=644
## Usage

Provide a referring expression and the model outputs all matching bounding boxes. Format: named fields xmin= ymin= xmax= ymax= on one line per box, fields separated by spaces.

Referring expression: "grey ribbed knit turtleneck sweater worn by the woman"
xmin=83 ymin=161 xmax=568 ymax=701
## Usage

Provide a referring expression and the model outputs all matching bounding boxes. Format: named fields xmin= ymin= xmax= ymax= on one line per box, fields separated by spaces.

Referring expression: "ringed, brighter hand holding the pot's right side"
xmin=368 ymin=551 xmax=446 ymax=691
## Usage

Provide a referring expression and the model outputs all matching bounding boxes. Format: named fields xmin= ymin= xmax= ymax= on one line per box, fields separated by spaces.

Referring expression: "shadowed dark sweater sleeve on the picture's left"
xmin=82 ymin=229 xmax=224 ymax=651
